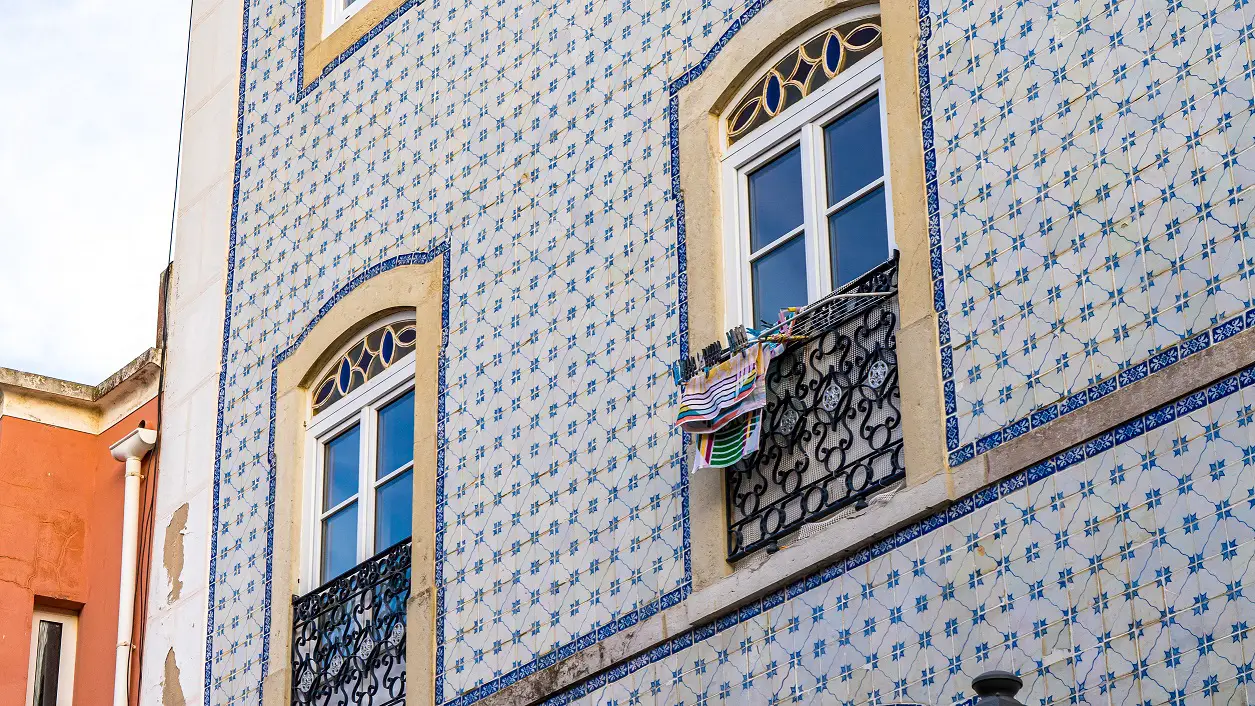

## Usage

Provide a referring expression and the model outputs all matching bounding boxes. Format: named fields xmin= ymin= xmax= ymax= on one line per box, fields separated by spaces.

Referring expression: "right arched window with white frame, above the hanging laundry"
xmin=723 ymin=8 xmax=892 ymax=327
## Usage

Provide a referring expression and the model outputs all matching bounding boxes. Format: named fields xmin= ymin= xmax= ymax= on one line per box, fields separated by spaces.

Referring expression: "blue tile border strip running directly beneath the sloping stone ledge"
xmin=542 ymin=358 xmax=1255 ymax=706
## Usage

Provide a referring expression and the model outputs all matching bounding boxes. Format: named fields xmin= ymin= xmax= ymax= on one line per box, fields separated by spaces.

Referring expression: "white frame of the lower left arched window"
xmin=297 ymin=323 xmax=414 ymax=592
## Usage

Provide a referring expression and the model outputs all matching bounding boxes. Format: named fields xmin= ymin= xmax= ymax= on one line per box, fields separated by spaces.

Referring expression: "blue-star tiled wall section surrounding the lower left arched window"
xmin=206 ymin=0 xmax=740 ymax=703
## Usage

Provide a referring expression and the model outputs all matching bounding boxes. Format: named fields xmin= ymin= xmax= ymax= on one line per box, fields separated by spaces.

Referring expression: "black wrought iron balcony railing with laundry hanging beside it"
xmin=727 ymin=255 xmax=906 ymax=561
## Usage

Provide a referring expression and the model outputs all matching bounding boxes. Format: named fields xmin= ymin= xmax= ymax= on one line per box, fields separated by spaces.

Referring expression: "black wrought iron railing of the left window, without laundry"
xmin=292 ymin=539 xmax=410 ymax=706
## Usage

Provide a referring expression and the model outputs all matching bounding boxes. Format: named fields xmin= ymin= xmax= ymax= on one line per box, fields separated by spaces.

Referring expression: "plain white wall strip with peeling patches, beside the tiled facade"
xmin=139 ymin=0 xmax=243 ymax=705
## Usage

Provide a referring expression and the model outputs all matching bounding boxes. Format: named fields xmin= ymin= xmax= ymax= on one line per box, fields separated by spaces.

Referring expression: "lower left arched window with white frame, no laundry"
xmin=302 ymin=319 xmax=415 ymax=588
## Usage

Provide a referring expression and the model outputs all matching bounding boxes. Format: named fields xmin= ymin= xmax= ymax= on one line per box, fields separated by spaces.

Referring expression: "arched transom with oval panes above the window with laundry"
xmin=728 ymin=18 xmax=881 ymax=143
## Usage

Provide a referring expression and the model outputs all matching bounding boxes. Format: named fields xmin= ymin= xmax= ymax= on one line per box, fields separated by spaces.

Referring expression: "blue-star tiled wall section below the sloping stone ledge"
xmin=546 ymin=370 xmax=1255 ymax=706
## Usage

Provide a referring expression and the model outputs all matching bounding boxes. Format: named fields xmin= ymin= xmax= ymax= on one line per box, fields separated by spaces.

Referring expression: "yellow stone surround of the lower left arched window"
xmin=262 ymin=255 xmax=448 ymax=706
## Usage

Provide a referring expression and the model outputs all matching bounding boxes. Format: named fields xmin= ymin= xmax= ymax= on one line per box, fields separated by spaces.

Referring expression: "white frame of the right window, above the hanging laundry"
xmin=719 ymin=5 xmax=896 ymax=329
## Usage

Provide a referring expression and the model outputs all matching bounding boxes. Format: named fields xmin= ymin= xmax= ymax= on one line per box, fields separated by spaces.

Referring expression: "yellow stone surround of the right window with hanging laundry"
xmin=676 ymin=0 xmax=949 ymax=592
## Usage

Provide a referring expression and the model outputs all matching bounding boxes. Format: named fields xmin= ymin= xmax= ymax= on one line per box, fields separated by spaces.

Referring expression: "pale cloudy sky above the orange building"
xmin=0 ymin=0 xmax=188 ymax=385
